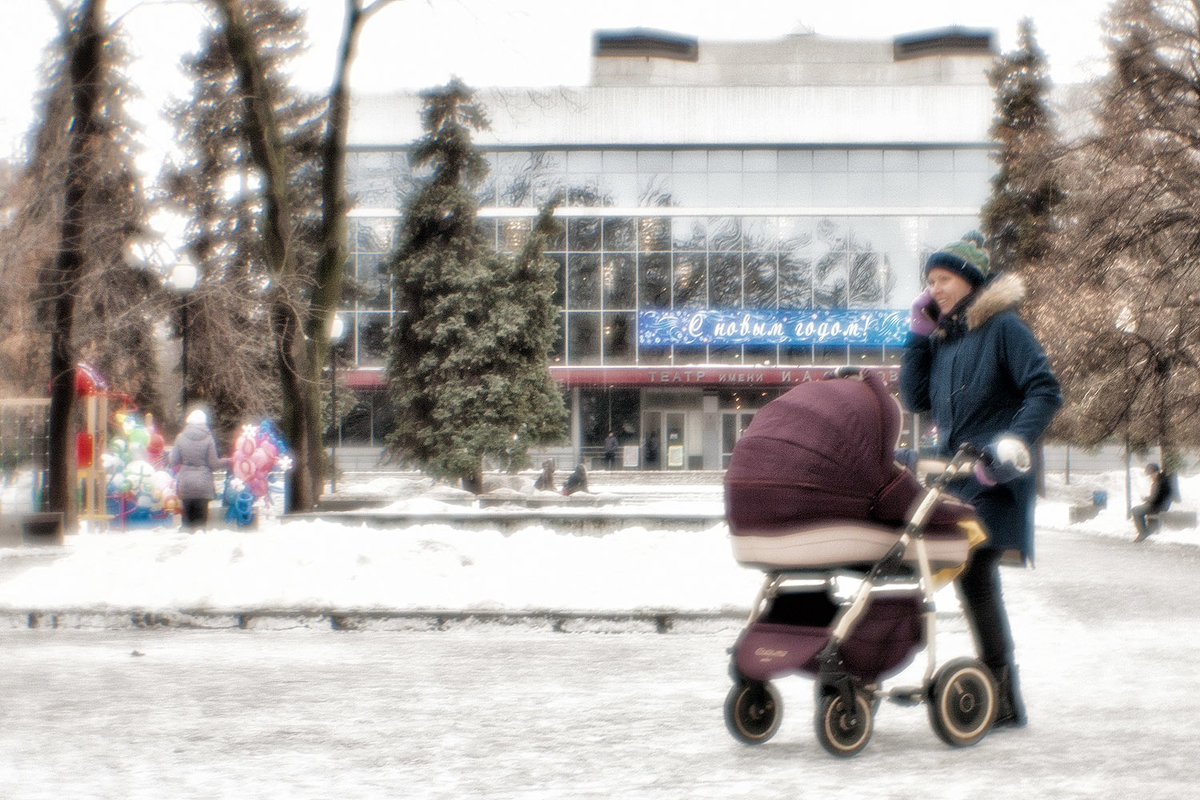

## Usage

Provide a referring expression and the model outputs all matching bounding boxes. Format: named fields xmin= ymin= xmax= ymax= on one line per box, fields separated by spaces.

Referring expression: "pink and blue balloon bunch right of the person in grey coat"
xmin=223 ymin=420 xmax=292 ymax=527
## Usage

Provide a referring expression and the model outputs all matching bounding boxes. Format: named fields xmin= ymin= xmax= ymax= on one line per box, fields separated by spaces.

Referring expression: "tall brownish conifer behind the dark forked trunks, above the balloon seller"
xmin=162 ymin=0 xmax=323 ymax=438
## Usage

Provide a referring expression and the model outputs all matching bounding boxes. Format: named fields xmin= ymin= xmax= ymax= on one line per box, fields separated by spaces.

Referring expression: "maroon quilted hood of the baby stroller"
xmin=725 ymin=373 xmax=920 ymax=535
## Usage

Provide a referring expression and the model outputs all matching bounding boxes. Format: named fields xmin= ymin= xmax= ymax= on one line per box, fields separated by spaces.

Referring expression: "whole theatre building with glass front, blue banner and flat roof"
xmin=346 ymin=29 xmax=995 ymax=469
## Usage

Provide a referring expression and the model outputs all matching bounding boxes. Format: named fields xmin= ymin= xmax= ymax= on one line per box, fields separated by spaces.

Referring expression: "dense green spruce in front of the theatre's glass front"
xmin=388 ymin=80 xmax=566 ymax=492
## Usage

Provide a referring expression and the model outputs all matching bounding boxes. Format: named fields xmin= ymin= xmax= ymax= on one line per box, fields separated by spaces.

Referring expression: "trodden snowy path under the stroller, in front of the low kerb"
xmin=0 ymin=531 xmax=1200 ymax=800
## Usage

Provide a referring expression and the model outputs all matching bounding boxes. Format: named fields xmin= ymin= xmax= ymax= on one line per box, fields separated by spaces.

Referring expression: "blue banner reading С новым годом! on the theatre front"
xmin=637 ymin=308 xmax=908 ymax=348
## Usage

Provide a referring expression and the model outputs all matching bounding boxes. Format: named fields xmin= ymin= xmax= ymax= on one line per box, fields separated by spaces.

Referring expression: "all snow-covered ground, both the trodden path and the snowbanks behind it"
xmin=0 ymin=473 xmax=1200 ymax=800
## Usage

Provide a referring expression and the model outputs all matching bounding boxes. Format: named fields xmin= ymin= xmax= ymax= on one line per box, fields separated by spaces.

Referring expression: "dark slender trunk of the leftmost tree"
xmin=47 ymin=0 xmax=104 ymax=529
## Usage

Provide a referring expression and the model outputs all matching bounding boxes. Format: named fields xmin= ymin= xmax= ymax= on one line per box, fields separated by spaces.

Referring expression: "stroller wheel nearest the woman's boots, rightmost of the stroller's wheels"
xmin=929 ymin=658 xmax=996 ymax=747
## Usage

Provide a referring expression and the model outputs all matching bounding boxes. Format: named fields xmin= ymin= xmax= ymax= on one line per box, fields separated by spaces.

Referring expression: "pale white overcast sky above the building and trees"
xmin=0 ymin=0 xmax=1109 ymax=159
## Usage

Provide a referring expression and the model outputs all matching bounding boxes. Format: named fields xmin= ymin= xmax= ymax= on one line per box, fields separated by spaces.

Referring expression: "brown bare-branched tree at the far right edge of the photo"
xmin=1044 ymin=0 xmax=1200 ymax=458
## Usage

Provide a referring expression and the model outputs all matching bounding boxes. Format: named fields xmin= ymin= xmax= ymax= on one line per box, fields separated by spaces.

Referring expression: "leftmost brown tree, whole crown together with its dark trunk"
xmin=0 ymin=2 xmax=162 ymax=525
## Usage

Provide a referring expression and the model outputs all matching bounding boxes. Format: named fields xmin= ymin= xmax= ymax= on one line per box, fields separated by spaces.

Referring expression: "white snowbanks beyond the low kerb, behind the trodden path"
xmin=0 ymin=462 xmax=1200 ymax=613
